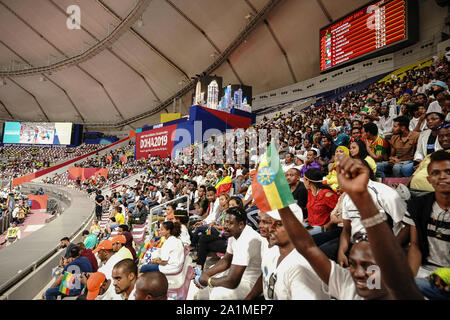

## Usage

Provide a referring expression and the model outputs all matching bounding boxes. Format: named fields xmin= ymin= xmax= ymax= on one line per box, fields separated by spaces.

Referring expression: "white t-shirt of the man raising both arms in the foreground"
xmin=322 ymin=260 xmax=364 ymax=300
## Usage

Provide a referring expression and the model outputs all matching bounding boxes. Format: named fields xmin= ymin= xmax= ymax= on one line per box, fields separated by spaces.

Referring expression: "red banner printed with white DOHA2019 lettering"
xmin=136 ymin=124 xmax=177 ymax=160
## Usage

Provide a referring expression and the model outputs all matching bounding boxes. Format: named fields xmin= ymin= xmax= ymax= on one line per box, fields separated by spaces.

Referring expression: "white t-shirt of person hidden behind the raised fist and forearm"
xmin=342 ymin=180 xmax=407 ymax=239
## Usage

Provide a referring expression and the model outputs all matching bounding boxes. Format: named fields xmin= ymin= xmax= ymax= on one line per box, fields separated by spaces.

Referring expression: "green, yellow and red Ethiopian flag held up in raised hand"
xmin=252 ymin=141 xmax=295 ymax=213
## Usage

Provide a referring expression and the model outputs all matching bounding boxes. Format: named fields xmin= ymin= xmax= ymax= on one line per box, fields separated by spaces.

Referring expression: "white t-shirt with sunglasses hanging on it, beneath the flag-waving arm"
xmin=262 ymin=246 xmax=330 ymax=300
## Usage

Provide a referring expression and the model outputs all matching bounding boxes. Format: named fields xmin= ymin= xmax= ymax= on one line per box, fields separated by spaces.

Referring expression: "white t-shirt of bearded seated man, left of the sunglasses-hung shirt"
xmin=227 ymin=226 xmax=261 ymax=284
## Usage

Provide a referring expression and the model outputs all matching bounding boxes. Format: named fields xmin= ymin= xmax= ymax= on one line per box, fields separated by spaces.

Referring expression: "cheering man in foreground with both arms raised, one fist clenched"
xmin=279 ymin=156 xmax=423 ymax=300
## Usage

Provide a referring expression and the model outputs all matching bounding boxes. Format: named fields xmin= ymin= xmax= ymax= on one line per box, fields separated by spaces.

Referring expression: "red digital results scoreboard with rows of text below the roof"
xmin=320 ymin=0 xmax=409 ymax=71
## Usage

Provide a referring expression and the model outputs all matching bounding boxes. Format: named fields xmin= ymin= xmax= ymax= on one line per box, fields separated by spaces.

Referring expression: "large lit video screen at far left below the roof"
xmin=3 ymin=122 xmax=72 ymax=145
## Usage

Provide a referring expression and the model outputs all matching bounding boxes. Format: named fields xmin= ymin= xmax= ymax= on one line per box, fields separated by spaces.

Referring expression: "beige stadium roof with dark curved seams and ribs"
xmin=0 ymin=0 xmax=368 ymax=129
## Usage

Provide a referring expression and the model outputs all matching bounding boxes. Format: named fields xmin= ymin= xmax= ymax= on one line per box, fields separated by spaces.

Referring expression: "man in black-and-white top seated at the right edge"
xmin=404 ymin=150 xmax=450 ymax=284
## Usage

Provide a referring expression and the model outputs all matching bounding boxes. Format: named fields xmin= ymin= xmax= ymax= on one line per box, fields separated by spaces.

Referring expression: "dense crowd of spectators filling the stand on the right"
xmin=7 ymin=53 xmax=450 ymax=300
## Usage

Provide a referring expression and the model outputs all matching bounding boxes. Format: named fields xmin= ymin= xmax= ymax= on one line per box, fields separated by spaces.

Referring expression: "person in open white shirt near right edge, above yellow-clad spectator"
xmin=414 ymin=112 xmax=444 ymax=163
